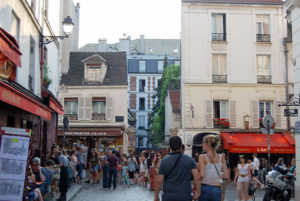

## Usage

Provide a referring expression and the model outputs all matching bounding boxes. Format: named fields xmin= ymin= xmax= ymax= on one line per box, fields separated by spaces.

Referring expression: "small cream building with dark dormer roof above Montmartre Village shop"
xmin=58 ymin=52 xmax=128 ymax=153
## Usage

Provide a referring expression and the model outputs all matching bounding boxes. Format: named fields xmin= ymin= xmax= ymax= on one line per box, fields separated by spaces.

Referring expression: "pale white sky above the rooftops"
xmin=74 ymin=0 xmax=181 ymax=47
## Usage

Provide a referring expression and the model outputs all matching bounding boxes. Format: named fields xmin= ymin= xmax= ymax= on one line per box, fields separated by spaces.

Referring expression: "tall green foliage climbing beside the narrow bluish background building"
xmin=148 ymin=56 xmax=180 ymax=144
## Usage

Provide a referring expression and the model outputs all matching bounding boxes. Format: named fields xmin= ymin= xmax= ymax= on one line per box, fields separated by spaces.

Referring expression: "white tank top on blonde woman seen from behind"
xmin=202 ymin=154 xmax=222 ymax=184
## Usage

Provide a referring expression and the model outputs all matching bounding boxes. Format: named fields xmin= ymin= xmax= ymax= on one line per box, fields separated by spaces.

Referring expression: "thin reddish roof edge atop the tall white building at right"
xmin=182 ymin=0 xmax=282 ymax=5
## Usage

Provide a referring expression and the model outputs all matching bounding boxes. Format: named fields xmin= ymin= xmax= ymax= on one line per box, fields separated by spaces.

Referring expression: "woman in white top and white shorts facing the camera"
xmin=234 ymin=155 xmax=251 ymax=201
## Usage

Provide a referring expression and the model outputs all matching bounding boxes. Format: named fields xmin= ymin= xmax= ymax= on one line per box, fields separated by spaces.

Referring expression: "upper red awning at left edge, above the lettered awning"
xmin=0 ymin=27 xmax=22 ymax=67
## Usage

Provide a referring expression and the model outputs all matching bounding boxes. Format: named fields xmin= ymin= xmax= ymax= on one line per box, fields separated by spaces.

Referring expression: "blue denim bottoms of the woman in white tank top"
xmin=198 ymin=184 xmax=222 ymax=201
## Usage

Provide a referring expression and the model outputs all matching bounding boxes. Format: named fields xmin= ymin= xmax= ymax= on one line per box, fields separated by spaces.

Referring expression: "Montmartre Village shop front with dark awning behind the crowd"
xmin=58 ymin=127 xmax=124 ymax=151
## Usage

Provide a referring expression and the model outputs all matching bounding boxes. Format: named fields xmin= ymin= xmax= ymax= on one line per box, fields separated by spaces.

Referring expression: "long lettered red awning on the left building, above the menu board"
xmin=0 ymin=81 xmax=51 ymax=120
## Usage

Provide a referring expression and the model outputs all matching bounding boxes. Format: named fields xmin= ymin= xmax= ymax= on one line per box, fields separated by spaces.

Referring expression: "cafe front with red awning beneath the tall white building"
xmin=221 ymin=132 xmax=295 ymax=173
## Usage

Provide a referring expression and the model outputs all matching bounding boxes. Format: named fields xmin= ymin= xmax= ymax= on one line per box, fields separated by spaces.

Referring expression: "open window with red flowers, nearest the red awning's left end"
xmin=213 ymin=101 xmax=230 ymax=128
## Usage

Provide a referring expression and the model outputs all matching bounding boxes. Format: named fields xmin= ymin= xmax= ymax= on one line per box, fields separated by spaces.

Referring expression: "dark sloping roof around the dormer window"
xmin=62 ymin=52 xmax=127 ymax=86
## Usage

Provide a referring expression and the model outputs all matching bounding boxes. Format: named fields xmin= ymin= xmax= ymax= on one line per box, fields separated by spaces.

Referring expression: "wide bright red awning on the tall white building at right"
xmin=221 ymin=133 xmax=295 ymax=154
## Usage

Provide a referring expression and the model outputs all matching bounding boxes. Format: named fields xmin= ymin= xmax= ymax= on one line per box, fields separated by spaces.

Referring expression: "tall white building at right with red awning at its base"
xmin=179 ymin=0 xmax=295 ymax=160
